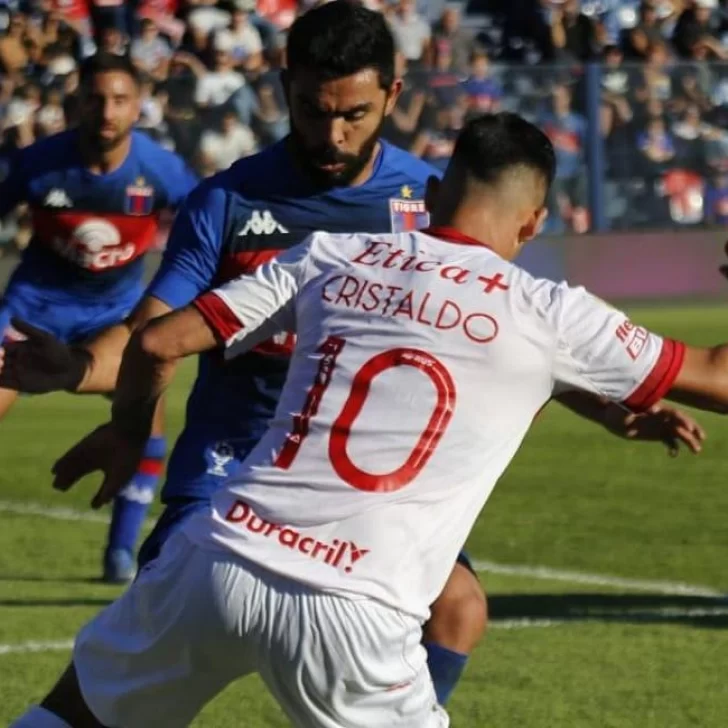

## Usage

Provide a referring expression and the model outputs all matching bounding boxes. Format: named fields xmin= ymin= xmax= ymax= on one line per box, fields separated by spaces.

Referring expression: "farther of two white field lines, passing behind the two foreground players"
xmin=0 ymin=500 xmax=728 ymax=597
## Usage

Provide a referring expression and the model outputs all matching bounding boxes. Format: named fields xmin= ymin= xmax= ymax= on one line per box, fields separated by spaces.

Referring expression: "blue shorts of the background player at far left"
xmin=0 ymin=282 xmax=141 ymax=344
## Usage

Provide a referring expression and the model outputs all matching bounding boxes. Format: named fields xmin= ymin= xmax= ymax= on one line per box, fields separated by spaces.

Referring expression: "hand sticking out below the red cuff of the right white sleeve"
xmin=605 ymin=404 xmax=706 ymax=457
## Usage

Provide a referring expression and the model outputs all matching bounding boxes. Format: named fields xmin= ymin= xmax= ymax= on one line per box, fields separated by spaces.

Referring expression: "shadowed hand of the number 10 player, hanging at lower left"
xmin=52 ymin=423 xmax=146 ymax=508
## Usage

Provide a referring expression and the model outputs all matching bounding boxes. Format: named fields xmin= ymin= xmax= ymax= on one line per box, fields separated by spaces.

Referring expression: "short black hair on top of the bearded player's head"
xmin=286 ymin=0 xmax=394 ymax=89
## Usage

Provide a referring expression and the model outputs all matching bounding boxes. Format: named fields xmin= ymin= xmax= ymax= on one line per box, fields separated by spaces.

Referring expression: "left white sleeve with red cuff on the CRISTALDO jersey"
xmin=193 ymin=236 xmax=313 ymax=354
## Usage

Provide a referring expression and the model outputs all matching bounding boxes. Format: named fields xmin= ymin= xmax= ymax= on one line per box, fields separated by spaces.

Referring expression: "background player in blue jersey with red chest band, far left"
xmin=0 ymin=54 xmax=198 ymax=582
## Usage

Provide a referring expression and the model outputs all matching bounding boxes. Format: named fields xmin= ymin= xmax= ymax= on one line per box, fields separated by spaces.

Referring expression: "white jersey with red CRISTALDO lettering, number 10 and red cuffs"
xmin=187 ymin=229 xmax=684 ymax=619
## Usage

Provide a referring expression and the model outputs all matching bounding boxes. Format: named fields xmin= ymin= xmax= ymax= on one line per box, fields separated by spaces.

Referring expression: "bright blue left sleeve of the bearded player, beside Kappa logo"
xmin=147 ymin=184 xmax=227 ymax=308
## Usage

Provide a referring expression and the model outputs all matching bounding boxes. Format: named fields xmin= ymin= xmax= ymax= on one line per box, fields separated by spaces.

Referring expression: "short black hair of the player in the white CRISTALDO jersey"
xmin=453 ymin=111 xmax=556 ymax=190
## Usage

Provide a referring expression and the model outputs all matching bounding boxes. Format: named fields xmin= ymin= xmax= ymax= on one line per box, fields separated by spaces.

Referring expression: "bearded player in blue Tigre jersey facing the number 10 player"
xmin=0 ymin=2 xmax=704 ymax=703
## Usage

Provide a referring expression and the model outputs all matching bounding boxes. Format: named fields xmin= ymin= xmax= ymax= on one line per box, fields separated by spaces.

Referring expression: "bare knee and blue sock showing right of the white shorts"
xmin=423 ymin=554 xmax=488 ymax=705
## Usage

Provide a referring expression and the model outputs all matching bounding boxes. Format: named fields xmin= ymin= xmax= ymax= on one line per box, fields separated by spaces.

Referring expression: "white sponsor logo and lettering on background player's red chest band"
xmin=53 ymin=218 xmax=136 ymax=270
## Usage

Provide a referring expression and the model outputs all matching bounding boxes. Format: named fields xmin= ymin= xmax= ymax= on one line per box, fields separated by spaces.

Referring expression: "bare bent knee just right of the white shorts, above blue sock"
xmin=425 ymin=564 xmax=488 ymax=653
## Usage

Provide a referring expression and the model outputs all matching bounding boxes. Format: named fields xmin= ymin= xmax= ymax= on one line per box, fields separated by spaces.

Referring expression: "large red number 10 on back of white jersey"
xmin=274 ymin=336 xmax=455 ymax=493
